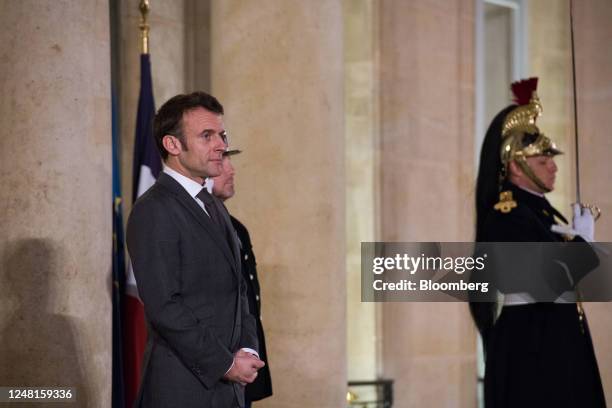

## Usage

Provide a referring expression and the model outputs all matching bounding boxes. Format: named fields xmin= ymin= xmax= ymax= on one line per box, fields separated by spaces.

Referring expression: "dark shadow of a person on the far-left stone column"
xmin=0 ymin=239 xmax=90 ymax=407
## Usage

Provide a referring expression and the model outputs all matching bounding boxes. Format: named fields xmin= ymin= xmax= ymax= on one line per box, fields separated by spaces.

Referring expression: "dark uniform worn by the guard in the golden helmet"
xmin=481 ymin=183 xmax=605 ymax=408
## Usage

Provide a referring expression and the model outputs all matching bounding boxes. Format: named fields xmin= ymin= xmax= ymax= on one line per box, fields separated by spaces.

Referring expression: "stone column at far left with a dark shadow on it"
xmin=0 ymin=0 xmax=112 ymax=407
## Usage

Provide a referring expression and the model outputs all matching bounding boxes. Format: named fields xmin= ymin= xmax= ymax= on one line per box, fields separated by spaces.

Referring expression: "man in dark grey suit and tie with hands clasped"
xmin=127 ymin=92 xmax=264 ymax=408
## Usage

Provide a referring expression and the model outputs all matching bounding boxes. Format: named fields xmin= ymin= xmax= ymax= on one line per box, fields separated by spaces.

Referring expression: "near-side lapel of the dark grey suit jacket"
xmin=157 ymin=173 xmax=239 ymax=273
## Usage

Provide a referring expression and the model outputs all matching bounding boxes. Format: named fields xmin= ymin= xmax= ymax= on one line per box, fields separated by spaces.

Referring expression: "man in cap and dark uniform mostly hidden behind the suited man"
xmin=213 ymin=150 xmax=272 ymax=407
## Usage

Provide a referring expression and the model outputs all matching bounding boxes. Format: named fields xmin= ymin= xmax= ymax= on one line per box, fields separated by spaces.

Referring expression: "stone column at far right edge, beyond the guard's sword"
xmin=574 ymin=0 xmax=612 ymax=405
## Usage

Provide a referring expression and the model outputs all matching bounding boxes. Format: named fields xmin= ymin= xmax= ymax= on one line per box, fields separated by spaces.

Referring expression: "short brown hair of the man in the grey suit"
xmin=153 ymin=92 xmax=223 ymax=161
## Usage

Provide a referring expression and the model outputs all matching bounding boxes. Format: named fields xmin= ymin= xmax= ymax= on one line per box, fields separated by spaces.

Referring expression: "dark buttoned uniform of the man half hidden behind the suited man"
xmin=230 ymin=216 xmax=272 ymax=401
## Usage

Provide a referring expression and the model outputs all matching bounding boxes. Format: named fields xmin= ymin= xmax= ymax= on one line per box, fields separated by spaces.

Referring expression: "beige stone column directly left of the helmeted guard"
xmin=380 ymin=0 xmax=477 ymax=408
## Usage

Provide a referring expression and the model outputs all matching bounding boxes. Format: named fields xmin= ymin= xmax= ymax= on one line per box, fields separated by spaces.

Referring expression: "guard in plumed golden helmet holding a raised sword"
xmin=470 ymin=78 xmax=605 ymax=408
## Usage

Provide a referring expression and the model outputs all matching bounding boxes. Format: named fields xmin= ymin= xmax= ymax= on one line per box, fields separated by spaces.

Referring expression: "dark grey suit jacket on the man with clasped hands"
xmin=127 ymin=173 xmax=257 ymax=408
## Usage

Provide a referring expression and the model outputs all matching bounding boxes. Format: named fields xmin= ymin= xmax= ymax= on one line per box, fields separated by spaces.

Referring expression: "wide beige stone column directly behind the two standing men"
xmin=211 ymin=0 xmax=346 ymax=408
